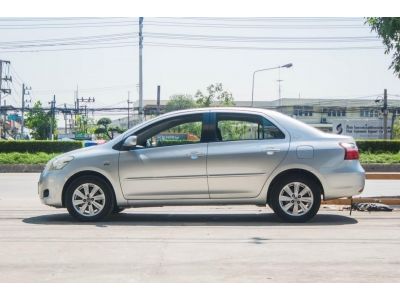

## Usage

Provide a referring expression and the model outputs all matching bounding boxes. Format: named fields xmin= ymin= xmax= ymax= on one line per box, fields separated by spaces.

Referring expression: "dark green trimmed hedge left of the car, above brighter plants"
xmin=0 ymin=141 xmax=82 ymax=153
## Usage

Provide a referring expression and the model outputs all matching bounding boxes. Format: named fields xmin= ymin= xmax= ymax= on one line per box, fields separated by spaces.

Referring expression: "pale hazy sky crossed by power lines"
xmin=0 ymin=17 xmax=400 ymax=119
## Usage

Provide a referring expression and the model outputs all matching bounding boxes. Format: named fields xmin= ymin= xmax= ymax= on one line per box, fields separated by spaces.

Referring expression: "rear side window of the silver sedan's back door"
xmin=216 ymin=113 xmax=285 ymax=141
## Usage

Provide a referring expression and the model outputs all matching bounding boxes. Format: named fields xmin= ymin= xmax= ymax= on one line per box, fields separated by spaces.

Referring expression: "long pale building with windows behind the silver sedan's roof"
xmin=111 ymin=98 xmax=400 ymax=138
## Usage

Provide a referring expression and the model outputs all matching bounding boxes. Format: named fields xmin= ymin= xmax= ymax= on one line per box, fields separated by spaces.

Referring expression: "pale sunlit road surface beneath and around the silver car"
xmin=0 ymin=174 xmax=400 ymax=282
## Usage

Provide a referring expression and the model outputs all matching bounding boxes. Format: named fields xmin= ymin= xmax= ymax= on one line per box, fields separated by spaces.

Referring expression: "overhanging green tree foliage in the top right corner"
xmin=366 ymin=17 xmax=400 ymax=78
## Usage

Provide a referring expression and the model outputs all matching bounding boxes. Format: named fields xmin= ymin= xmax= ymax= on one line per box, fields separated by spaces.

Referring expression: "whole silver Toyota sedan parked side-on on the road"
xmin=39 ymin=108 xmax=365 ymax=222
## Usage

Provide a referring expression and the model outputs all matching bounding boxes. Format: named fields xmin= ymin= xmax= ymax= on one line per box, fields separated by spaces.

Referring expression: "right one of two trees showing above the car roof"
xmin=195 ymin=83 xmax=235 ymax=107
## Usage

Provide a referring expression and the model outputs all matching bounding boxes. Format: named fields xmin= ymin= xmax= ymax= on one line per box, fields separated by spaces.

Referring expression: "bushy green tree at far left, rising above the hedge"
xmin=25 ymin=101 xmax=57 ymax=140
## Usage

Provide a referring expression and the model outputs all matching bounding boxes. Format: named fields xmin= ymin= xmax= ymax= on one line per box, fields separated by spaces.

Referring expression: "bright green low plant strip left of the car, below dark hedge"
xmin=0 ymin=152 xmax=60 ymax=165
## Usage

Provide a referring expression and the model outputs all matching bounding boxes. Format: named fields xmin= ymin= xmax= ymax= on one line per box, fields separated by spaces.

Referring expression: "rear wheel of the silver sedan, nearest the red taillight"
xmin=268 ymin=175 xmax=321 ymax=223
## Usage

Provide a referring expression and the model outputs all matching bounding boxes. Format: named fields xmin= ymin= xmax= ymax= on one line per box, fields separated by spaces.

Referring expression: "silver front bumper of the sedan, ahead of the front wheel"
xmin=38 ymin=170 xmax=65 ymax=207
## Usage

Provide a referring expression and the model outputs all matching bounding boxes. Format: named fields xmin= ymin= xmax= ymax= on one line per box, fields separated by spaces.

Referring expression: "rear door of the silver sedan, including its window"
xmin=207 ymin=112 xmax=290 ymax=199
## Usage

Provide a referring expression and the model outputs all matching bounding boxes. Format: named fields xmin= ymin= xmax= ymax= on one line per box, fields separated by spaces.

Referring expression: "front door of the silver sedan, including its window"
xmin=119 ymin=113 xmax=209 ymax=200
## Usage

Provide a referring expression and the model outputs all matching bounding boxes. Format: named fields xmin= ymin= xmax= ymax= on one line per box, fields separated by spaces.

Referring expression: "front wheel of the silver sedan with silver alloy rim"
xmin=65 ymin=176 xmax=114 ymax=221
